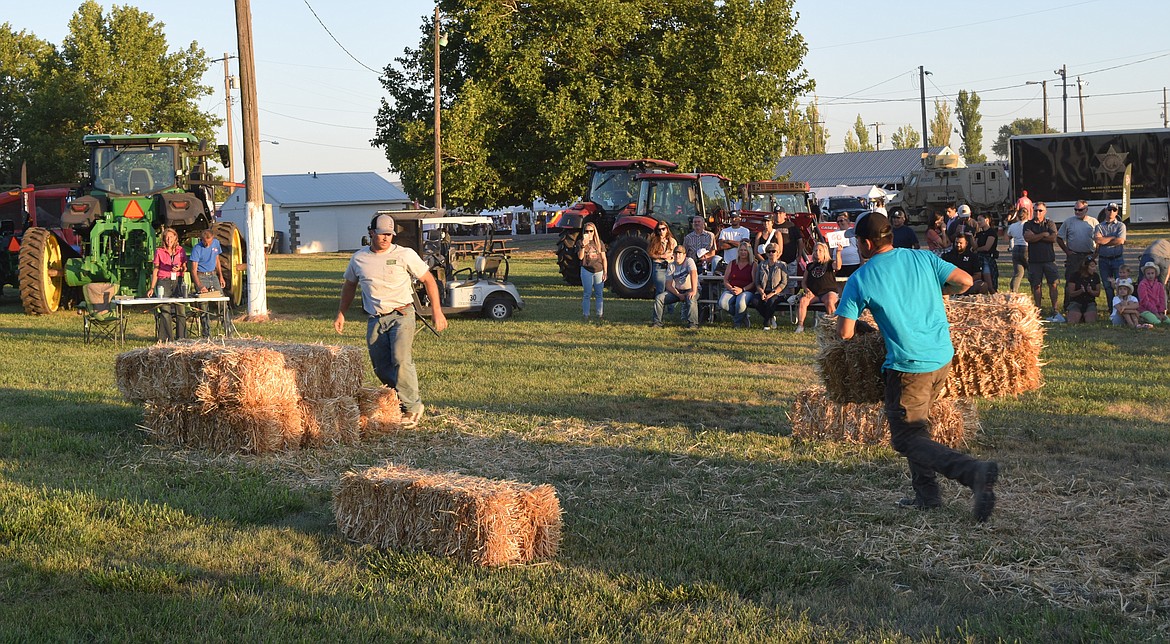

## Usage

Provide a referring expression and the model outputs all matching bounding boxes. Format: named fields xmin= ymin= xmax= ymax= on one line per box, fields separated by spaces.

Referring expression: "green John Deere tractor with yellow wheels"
xmin=20 ymin=132 xmax=245 ymax=314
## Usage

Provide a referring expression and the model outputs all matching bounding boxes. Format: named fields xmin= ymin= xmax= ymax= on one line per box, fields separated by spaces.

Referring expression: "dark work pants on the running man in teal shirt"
xmin=882 ymin=364 xmax=979 ymax=505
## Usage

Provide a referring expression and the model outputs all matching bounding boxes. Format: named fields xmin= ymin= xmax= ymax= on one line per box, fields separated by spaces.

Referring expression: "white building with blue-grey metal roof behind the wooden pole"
xmin=220 ymin=172 xmax=411 ymax=253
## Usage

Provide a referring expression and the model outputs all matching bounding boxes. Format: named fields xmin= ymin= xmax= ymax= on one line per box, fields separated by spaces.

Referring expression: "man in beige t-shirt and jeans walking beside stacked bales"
xmin=333 ymin=214 xmax=447 ymax=427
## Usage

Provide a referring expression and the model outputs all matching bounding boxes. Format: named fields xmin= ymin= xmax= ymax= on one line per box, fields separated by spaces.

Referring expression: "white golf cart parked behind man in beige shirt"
xmin=386 ymin=211 xmax=524 ymax=320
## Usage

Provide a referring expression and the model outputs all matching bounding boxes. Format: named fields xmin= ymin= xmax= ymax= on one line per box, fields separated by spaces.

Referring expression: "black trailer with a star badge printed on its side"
xmin=1011 ymin=128 xmax=1170 ymax=224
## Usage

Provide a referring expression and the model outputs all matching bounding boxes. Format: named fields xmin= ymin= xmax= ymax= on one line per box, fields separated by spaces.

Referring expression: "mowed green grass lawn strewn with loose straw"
xmin=0 ymin=235 xmax=1170 ymax=642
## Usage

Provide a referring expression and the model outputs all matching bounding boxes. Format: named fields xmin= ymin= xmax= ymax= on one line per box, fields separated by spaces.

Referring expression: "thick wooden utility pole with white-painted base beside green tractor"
xmin=235 ymin=0 xmax=268 ymax=322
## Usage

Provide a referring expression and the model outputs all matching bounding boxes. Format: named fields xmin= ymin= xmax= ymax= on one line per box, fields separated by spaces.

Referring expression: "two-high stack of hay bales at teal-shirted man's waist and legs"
xmin=790 ymin=293 xmax=1044 ymax=443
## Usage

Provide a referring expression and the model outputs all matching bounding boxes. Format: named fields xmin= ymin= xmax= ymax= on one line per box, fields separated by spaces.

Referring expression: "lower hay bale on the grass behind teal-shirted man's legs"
xmin=789 ymin=386 xmax=980 ymax=447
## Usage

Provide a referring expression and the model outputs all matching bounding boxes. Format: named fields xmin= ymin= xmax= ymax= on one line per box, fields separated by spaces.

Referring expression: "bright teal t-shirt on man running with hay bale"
xmin=837 ymin=248 xmax=955 ymax=374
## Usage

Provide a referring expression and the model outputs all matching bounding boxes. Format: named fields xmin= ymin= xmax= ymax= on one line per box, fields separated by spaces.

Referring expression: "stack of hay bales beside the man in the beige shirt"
xmin=115 ymin=340 xmax=397 ymax=453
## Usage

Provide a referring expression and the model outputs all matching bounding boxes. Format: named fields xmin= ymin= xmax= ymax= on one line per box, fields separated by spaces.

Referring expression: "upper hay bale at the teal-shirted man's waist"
xmin=815 ymin=293 xmax=1044 ymax=403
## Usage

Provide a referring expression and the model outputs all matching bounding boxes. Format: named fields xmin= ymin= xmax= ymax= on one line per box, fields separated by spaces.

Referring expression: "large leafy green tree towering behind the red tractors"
xmin=373 ymin=0 xmax=813 ymax=207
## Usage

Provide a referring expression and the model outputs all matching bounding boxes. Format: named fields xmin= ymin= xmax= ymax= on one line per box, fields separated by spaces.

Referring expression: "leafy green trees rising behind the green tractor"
xmin=0 ymin=0 xmax=219 ymax=184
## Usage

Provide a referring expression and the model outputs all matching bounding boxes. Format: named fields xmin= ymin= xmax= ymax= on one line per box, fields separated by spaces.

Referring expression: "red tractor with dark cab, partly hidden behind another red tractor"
xmin=557 ymin=159 xmax=679 ymax=285
